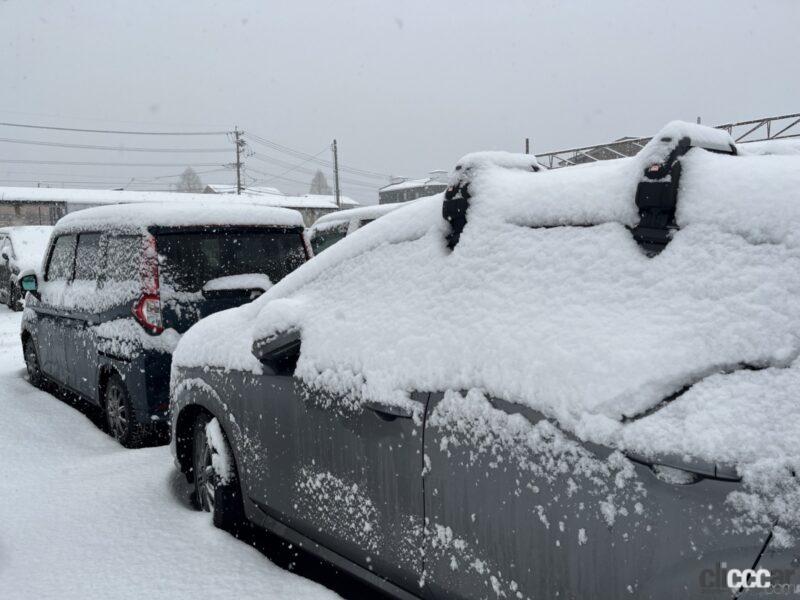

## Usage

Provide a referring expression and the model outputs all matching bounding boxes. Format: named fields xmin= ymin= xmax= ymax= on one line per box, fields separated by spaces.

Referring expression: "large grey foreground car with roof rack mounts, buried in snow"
xmin=171 ymin=122 xmax=800 ymax=599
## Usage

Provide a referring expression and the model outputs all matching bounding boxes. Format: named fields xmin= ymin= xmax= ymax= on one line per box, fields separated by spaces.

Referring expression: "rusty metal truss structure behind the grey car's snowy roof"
xmin=536 ymin=113 xmax=800 ymax=169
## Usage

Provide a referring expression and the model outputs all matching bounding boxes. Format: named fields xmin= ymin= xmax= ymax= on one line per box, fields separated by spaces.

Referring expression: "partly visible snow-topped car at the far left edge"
xmin=0 ymin=225 xmax=53 ymax=310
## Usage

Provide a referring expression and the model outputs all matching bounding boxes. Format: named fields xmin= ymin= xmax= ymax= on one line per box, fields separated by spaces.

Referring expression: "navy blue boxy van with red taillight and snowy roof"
xmin=21 ymin=202 xmax=308 ymax=446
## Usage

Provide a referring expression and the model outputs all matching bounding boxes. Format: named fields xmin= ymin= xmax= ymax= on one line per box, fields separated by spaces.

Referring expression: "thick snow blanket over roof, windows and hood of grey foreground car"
xmin=174 ymin=124 xmax=800 ymax=540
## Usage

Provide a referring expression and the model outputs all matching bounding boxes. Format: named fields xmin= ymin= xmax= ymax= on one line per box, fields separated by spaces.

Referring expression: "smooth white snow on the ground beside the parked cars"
xmin=0 ymin=307 xmax=335 ymax=600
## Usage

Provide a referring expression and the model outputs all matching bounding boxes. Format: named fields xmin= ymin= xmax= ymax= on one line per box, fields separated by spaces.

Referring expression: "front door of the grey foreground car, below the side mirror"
xmin=240 ymin=336 xmax=427 ymax=592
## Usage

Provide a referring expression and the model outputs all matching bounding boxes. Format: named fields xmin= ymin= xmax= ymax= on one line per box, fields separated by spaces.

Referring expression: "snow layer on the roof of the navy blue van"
xmin=55 ymin=196 xmax=303 ymax=233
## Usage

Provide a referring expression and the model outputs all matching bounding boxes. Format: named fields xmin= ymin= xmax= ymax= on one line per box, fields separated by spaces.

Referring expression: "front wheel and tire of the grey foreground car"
xmin=192 ymin=414 xmax=245 ymax=534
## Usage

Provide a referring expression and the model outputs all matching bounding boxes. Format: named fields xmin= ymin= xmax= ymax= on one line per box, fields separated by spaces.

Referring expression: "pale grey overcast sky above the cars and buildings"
xmin=0 ymin=0 xmax=800 ymax=202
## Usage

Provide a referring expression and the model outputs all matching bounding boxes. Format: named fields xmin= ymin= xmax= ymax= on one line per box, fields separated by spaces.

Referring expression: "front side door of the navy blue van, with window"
xmin=35 ymin=235 xmax=77 ymax=384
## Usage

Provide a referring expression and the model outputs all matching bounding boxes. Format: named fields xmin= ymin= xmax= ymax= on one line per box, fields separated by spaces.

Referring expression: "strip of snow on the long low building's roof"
xmin=0 ymin=187 xmax=358 ymax=209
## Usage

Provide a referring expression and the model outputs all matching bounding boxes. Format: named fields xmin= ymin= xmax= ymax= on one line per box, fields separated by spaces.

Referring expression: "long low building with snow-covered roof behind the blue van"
xmin=0 ymin=186 xmax=358 ymax=227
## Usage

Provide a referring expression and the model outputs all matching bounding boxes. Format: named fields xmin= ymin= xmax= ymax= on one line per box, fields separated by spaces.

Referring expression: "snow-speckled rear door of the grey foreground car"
xmin=425 ymin=390 xmax=767 ymax=599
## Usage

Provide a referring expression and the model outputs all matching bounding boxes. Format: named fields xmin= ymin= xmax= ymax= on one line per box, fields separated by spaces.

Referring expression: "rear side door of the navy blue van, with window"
xmin=62 ymin=233 xmax=102 ymax=399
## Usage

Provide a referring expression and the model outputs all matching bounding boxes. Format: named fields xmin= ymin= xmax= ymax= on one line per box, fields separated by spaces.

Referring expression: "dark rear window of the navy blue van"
xmin=156 ymin=229 xmax=306 ymax=292
